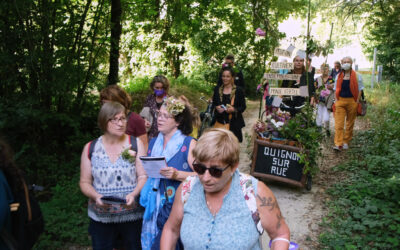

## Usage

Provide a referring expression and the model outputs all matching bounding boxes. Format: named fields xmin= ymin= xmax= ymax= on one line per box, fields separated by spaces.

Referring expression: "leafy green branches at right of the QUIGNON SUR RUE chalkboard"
xmin=280 ymin=103 xmax=323 ymax=176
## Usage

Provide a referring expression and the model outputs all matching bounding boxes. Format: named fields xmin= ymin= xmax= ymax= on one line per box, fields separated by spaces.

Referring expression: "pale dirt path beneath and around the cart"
xmin=239 ymin=101 xmax=368 ymax=250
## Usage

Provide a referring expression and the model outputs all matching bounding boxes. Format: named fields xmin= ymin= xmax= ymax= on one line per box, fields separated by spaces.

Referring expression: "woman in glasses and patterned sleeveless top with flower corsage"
xmin=79 ymin=102 xmax=147 ymax=250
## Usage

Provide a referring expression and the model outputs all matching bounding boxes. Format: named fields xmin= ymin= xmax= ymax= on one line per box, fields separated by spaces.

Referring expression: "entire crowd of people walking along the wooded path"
xmin=0 ymin=51 xmax=363 ymax=249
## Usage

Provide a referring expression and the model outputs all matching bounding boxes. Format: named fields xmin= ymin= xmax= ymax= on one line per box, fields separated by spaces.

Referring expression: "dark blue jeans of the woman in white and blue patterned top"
xmin=89 ymin=219 xmax=142 ymax=250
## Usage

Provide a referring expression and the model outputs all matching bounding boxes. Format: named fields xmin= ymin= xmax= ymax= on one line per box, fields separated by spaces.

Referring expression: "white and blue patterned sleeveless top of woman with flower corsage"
xmin=88 ymin=136 xmax=144 ymax=223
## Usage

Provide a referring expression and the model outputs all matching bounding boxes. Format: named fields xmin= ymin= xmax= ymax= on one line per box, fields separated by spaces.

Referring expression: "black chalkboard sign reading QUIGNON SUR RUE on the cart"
xmin=251 ymin=139 xmax=305 ymax=186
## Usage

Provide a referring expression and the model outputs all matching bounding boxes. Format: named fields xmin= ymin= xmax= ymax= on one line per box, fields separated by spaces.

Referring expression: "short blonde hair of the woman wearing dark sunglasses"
xmin=193 ymin=128 xmax=240 ymax=167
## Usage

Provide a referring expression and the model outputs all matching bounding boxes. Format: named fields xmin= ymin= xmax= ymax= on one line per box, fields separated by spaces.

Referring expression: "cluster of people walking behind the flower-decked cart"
xmin=263 ymin=55 xmax=364 ymax=151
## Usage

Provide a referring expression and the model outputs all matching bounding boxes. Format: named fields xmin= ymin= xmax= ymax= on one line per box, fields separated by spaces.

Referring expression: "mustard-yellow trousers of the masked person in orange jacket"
xmin=335 ymin=97 xmax=358 ymax=146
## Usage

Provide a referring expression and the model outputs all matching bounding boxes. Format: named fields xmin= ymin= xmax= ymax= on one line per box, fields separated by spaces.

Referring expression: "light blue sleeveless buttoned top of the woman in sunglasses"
xmin=180 ymin=171 xmax=261 ymax=250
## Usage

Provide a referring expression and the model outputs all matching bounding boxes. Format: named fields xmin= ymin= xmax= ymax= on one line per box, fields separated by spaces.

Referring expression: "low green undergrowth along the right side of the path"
xmin=320 ymin=83 xmax=400 ymax=249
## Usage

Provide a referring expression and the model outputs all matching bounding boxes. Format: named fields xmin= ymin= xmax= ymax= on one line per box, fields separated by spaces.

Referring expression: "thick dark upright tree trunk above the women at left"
xmin=107 ymin=0 xmax=122 ymax=85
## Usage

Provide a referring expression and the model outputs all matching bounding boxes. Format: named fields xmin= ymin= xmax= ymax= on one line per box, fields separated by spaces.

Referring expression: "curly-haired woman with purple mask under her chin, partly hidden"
xmin=143 ymin=75 xmax=169 ymax=139
